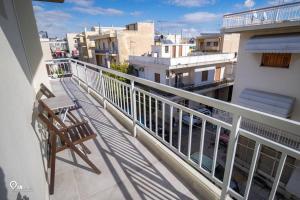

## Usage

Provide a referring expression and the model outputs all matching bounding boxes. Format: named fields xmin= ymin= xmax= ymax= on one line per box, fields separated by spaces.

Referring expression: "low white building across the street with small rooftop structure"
xmin=129 ymin=43 xmax=236 ymax=107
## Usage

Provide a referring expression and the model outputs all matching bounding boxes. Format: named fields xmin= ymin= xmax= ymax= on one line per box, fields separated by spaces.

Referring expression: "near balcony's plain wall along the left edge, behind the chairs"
xmin=0 ymin=0 xmax=48 ymax=200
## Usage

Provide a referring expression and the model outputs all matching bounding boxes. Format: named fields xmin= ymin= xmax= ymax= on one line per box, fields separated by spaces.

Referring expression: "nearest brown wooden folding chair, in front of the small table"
xmin=38 ymin=100 xmax=101 ymax=194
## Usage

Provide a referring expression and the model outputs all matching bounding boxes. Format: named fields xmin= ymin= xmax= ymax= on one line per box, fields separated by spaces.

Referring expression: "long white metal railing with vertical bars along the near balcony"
xmin=46 ymin=59 xmax=300 ymax=199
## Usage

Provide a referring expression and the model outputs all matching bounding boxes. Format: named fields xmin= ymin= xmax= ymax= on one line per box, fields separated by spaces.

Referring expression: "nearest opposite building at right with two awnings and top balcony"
xmin=220 ymin=2 xmax=300 ymax=198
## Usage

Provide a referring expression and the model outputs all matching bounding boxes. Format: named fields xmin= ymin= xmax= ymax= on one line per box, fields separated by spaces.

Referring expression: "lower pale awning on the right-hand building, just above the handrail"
xmin=239 ymin=88 xmax=295 ymax=118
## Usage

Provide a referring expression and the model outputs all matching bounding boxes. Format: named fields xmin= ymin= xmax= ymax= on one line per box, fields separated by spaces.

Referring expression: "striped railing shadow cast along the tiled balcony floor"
xmin=61 ymin=79 xmax=196 ymax=199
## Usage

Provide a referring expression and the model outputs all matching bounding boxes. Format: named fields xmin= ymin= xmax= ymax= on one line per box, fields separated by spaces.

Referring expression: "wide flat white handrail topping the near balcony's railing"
xmin=59 ymin=58 xmax=300 ymax=134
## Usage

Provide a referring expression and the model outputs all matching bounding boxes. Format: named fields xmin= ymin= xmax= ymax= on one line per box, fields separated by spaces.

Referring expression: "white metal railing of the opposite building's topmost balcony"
xmin=223 ymin=2 xmax=300 ymax=29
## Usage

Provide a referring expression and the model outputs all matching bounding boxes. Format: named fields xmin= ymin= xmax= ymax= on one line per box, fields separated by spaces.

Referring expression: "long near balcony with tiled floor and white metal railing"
xmin=48 ymin=59 xmax=300 ymax=199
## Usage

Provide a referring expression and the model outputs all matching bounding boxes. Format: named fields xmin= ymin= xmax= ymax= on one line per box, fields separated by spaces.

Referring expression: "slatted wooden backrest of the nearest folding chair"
xmin=38 ymin=100 xmax=67 ymax=132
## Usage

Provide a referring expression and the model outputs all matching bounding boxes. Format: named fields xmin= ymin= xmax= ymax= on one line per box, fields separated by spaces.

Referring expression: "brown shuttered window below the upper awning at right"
xmin=261 ymin=53 xmax=291 ymax=68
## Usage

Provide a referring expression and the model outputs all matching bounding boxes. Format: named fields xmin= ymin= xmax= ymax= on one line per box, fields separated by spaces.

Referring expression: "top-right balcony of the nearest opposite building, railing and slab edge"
xmin=222 ymin=2 xmax=300 ymax=33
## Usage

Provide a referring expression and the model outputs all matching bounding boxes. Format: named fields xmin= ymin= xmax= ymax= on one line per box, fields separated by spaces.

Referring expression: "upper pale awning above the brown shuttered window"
xmin=245 ymin=33 xmax=300 ymax=53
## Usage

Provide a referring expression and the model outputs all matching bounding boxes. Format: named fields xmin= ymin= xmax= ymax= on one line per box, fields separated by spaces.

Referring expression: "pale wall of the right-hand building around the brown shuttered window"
xmin=232 ymin=29 xmax=300 ymax=121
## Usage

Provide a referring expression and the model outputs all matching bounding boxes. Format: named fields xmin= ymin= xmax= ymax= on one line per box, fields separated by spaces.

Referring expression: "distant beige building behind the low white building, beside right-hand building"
xmin=195 ymin=33 xmax=240 ymax=53
